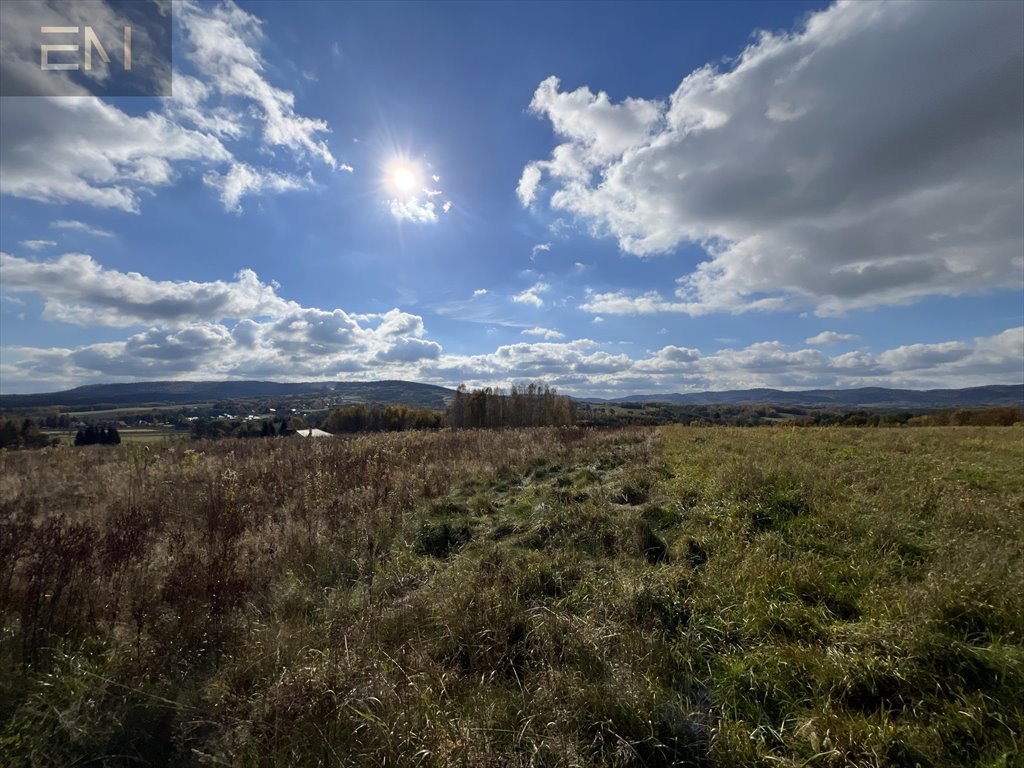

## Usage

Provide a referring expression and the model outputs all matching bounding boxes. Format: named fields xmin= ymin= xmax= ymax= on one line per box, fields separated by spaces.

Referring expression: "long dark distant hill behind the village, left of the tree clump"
xmin=0 ymin=381 xmax=455 ymax=410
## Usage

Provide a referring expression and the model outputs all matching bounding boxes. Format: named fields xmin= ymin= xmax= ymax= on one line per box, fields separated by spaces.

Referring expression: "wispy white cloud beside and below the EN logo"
xmin=0 ymin=1 xmax=339 ymax=213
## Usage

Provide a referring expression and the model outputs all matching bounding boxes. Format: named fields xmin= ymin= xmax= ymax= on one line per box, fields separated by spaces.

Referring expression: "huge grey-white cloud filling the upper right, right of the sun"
xmin=518 ymin=2 xmax=1024 ymax=314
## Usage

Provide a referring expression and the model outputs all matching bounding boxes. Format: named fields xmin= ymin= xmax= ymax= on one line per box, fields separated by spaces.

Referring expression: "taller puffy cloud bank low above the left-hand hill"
xmin=0 ymin=254 xmax=456 ymax=389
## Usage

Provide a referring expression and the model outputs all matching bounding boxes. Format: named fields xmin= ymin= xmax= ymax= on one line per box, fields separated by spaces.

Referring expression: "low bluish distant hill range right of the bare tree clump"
xmin=585 ymin=384 xmax=1024 ymax=409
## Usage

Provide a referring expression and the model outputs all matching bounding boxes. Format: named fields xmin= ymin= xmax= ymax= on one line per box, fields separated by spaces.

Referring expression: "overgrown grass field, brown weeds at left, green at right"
xmin=0 ymin=427 xmax=1024 ymax=768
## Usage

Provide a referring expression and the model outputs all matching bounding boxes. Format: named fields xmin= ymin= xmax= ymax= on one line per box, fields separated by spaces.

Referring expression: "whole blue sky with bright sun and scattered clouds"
xmin=0 ymin=0 xmax=1024 ymax=396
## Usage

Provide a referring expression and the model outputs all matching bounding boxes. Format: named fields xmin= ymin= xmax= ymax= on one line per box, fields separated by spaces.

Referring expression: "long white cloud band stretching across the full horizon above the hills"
xmin=0 ymin=259 xmax=1024 ymax=394
